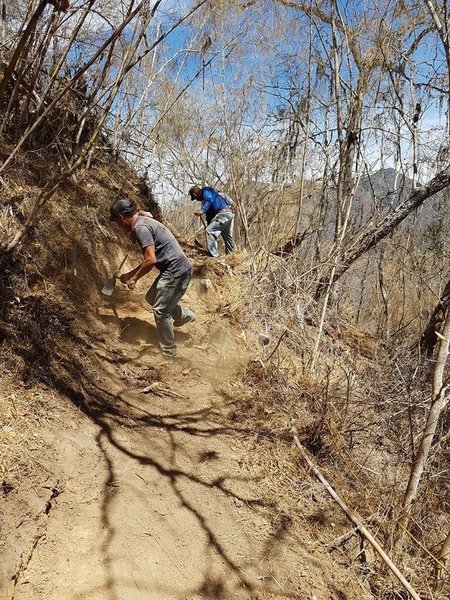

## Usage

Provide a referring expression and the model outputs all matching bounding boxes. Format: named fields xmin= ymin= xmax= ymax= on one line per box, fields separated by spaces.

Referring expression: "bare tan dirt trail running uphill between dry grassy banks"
xmin=5 ymin=280 xmax=314 ymax=600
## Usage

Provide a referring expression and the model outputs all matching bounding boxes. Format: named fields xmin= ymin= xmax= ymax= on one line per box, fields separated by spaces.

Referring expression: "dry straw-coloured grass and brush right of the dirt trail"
xmin=209 ymin=258 xmax=450 ymax=600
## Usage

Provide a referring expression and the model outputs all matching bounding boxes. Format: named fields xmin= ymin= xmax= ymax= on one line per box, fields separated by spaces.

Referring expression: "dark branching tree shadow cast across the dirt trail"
xmin=60 ymin=364 xmax=295 ymax=600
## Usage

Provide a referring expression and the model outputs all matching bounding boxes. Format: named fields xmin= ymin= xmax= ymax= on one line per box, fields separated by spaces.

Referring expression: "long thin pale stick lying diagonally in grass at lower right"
xmin=291 ymin=424 xmax=420 ymax=600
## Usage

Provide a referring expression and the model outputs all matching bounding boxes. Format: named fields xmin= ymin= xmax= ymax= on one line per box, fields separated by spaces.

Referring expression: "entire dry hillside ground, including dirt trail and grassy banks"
xmin=0 ymin=146 xmax=436 ymax=600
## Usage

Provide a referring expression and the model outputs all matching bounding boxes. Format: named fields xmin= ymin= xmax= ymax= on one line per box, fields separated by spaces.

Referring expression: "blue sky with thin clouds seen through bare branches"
xmin=26 ymin=0 xmax=447 ymax=192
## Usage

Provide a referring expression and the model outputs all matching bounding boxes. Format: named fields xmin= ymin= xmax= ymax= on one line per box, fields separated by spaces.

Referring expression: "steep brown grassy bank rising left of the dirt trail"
xmin=0 ymin=144 xmax=155 ymax=488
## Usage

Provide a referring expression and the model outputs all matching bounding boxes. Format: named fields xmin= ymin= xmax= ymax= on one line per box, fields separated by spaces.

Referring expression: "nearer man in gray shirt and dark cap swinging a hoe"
xmin=110 ymin=199 xmax=195 ymax=357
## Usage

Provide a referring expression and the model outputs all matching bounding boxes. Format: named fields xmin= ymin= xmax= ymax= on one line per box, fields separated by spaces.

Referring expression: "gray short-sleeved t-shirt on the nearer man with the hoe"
xmin=134 ymin=216 xmax=192 ymax=277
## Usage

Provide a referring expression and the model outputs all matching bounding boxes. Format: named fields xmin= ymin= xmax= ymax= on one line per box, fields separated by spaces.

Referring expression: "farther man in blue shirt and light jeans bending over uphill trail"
xmin=189 ymin=185 xmax=236 ymax=258
